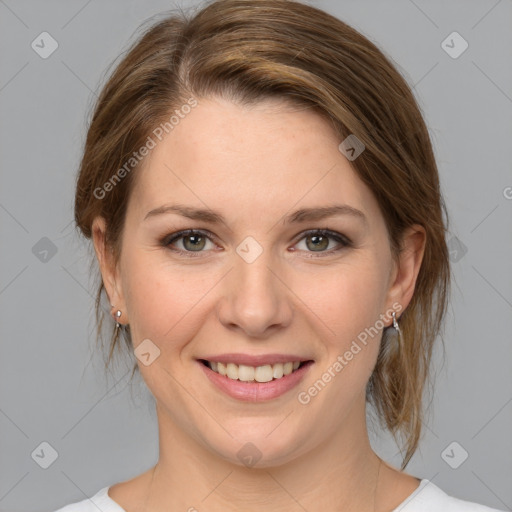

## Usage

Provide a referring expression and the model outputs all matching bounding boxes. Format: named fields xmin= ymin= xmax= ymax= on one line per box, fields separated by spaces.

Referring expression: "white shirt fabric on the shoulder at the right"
xmin=400 ymin=479 xmax=503 ymax=512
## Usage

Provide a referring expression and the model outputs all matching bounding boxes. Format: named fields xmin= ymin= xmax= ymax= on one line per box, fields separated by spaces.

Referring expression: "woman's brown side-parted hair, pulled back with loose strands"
xmin=75 ymin=0 xmax=450 ymax=470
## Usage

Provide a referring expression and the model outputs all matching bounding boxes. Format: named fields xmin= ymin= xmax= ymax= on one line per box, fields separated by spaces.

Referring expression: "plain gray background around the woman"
xmin=0 ymin=0 xmax=512 ymax=512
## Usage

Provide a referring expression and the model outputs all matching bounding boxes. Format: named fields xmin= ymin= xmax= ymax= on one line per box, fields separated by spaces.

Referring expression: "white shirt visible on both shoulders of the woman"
xmin=55 ymin=479 xmax=504 ymax=512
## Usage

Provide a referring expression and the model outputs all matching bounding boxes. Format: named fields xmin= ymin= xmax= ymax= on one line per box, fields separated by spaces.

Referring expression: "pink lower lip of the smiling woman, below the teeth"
xmin=197 ymin=361 xmax=313 ymax=402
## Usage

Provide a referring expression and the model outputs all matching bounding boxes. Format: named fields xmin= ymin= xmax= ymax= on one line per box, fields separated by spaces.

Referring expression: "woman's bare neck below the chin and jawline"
xmin=144 ymin=405 xmax=381 ymax=512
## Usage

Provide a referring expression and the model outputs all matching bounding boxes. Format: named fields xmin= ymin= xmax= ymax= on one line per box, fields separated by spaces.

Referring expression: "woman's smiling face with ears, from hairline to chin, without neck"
xmin=93 ymin=98 xmax=422 ymax=466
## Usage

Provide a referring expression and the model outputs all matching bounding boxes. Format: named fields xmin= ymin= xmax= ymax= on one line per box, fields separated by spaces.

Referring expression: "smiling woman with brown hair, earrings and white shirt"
xmin=55 ymin=0 xmax=504 ymax=512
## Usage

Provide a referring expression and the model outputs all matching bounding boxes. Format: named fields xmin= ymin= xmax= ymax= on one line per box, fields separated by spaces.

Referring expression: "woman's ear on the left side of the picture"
xmin=91 ymin=217 xmax=127 ymax=323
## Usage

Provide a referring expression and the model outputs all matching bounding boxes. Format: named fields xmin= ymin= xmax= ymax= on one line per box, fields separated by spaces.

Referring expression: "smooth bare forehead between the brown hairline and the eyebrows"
xmin=126 ymin=98 xmax=378 ymax=228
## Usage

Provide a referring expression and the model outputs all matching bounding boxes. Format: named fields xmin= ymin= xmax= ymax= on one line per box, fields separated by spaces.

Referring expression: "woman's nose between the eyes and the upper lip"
xmin=217 ymin=244 xmax=293 ymax=338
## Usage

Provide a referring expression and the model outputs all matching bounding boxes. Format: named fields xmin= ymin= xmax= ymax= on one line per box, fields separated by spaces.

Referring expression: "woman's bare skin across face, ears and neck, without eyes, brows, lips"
xmin=93 ymin=97 xmax=425 ymax=512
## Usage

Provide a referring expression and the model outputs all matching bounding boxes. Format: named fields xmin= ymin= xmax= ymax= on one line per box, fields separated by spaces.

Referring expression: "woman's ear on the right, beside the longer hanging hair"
xmin=386 ymin=224 xmax=427 ymax=324
